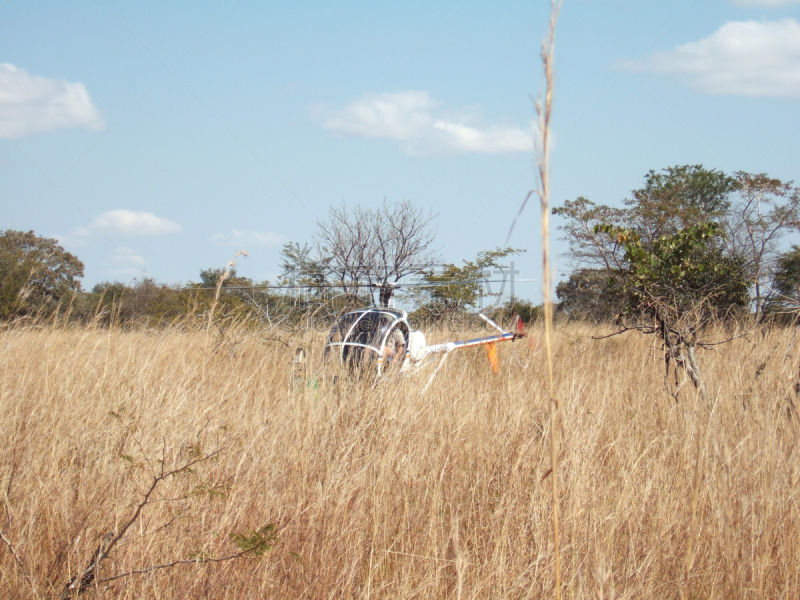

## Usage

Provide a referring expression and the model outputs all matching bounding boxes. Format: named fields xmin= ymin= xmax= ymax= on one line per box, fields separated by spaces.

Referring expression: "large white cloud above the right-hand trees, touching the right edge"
xmin=631 ymin=18 xmax=800 ymax=98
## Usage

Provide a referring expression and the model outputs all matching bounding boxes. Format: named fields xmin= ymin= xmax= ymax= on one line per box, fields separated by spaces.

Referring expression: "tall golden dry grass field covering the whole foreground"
xmin=0 ymin=324 xmax=800 ymax=599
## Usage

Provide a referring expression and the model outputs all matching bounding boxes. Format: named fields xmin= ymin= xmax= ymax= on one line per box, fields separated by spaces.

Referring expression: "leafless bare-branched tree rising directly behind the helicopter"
xmin=315 ymin=199 xmax=437 ymax=306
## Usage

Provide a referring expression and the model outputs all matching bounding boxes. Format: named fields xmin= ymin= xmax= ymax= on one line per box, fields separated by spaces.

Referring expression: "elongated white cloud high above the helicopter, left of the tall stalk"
xmin=311 ymin=90 xmax=533 ymax=155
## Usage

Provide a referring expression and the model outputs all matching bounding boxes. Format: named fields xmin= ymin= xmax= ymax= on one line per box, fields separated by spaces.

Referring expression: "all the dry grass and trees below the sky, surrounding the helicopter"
xmin=0 ymin=166 xmax=800 ymax=599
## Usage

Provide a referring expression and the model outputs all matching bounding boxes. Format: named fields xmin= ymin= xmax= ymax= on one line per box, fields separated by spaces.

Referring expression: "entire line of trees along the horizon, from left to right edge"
xmin=0 ymin=165 xmax=800 ymax=325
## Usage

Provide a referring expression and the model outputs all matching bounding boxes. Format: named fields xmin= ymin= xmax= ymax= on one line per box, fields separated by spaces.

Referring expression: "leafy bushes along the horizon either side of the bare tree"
xmin=0 ymin=229 xmax=535 ymax=327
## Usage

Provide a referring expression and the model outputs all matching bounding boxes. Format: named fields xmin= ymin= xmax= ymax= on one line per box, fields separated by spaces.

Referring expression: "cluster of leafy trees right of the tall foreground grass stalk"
xmin=553 ymin=165 xmax=800 ymax=321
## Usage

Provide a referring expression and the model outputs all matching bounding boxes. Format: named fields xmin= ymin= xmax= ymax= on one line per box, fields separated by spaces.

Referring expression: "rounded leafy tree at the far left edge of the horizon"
xmin=0 ymin=229 xmax=83 ymax=319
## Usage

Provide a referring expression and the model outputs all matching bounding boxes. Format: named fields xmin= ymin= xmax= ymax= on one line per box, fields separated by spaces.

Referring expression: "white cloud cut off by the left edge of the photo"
xmin=0 ymin=63 xmax=105 ymax=139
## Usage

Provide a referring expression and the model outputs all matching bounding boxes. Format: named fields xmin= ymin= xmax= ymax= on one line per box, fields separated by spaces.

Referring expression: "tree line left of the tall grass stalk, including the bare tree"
xmin=0 ymin=201 xmax=538 ymax=325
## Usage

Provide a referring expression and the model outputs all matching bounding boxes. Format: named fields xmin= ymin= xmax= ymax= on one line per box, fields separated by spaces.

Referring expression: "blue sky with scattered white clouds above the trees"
xmin=0 ymin=0 xmax=800 ymax=300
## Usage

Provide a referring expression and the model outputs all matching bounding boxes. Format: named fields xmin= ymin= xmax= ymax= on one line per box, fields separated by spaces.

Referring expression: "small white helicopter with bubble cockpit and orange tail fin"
xmin=323 ymin=307 xmax=525 ymax=378
